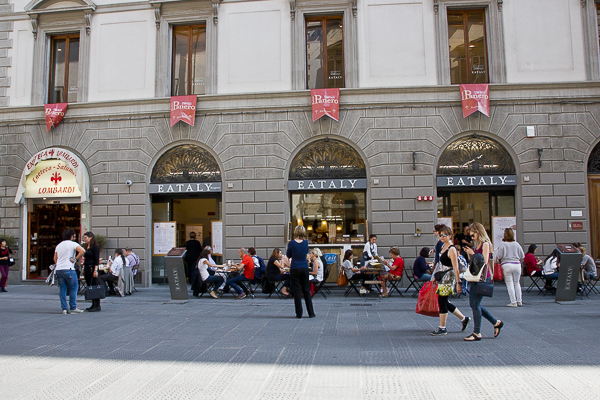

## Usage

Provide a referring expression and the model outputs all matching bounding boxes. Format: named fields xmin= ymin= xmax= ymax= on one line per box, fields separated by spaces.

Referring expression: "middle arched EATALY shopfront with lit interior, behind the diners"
xmin=288 ymin=139 xmax=368 ymax=282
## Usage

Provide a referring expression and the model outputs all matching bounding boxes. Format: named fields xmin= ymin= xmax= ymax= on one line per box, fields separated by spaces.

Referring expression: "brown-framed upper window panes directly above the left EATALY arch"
xmin=171 ymin=24 xmax=206 ymax=96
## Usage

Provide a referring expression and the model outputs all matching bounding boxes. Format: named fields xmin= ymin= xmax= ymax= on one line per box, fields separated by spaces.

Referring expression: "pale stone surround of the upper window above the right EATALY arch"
xmin=434 ymin=0 xmax=506 ymax=85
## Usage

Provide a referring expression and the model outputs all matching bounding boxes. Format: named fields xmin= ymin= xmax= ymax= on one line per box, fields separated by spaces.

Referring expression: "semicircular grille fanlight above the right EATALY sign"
xmin=437 ymin=135 xmax=516 ymax=176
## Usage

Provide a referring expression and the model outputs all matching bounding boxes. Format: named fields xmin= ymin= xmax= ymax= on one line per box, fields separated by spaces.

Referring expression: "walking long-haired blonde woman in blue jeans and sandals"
xmin=465 ymin=222 xmax=504 ymax=342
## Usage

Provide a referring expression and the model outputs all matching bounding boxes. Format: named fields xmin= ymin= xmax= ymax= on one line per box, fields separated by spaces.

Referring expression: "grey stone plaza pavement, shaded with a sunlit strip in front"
xmin=0 ymin=285 xmax=600 ymax=400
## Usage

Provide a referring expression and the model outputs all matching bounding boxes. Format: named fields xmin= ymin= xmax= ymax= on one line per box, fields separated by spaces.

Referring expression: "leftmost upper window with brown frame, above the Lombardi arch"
xmin=48 ymin=35 xmax=79 ymax=104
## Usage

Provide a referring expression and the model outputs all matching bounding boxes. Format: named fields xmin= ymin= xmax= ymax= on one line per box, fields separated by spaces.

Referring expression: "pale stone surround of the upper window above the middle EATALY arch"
xmin=291 ymin=0 xmax=358 ymax=90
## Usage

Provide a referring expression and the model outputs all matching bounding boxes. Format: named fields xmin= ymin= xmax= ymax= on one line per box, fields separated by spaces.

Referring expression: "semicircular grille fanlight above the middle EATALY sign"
xmin=290 ymin=139 xmax=367 ymax=179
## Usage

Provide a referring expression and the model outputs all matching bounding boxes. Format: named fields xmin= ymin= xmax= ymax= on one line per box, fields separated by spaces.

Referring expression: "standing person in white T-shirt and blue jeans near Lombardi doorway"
xmin=54 ymin=228 xmax=85 ymax=314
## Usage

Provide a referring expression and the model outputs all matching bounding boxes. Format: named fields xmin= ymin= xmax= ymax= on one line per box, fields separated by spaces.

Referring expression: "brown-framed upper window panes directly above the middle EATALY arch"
xmin=306 ymin=15 xmax=345 ymax=89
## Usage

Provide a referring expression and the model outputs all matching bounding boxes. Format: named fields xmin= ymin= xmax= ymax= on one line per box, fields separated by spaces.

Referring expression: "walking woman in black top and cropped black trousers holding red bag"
xmin=431 ymin=225 xmax=471 ymax=336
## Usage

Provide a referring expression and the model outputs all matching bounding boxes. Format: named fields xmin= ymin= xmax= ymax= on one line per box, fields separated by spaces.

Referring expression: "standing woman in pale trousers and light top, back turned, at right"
xmin=496 ymin=228 xmax=525 ymax=307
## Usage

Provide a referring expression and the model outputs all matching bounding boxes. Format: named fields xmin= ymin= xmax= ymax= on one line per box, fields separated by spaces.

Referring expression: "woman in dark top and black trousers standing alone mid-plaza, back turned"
xmin=286 ymin=225 xmax=316 ymax=318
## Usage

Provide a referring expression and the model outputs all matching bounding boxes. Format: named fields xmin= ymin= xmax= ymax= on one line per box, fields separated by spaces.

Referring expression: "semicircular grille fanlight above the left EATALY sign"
xmin=150 ymin=144 xmax=221 ymax=183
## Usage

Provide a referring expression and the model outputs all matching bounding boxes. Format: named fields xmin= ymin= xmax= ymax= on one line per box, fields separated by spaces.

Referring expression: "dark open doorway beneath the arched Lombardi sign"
xmin=27 ymin=204 xmax=81 ymax=279
